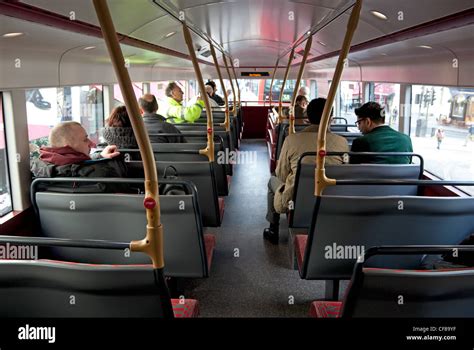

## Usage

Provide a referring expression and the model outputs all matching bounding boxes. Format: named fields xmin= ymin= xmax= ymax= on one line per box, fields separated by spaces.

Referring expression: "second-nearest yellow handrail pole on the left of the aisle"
xmin=182 ymin=21 xmax=214 ymax=162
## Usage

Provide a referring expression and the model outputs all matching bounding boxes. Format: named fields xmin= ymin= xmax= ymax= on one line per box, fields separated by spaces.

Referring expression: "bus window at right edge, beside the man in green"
xmin=410 ymin=85 xmax=474 ymax=194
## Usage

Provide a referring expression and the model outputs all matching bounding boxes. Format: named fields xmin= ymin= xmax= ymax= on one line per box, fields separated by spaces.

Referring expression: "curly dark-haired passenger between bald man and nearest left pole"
xmin=102 ymin=106 xmax=138 ymax=148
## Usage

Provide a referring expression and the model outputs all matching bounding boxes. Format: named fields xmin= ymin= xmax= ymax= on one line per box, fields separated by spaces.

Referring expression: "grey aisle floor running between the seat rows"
xmin=184 ymin=140 xmax=336 ymax=317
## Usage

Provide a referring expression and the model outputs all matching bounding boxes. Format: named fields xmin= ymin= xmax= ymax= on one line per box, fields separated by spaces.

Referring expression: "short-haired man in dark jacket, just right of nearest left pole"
xmin=138 ymin=94 xmax=186 ymax=143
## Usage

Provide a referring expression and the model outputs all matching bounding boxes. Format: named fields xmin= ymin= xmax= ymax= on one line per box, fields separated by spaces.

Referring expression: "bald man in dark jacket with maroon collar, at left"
xmin=31 ymin=121 xmax=127 ymax=177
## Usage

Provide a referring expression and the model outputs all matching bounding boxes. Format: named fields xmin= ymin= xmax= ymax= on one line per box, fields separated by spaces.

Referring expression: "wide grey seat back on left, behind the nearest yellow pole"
xmin=34 ymin=182 xmax=208 ymax=277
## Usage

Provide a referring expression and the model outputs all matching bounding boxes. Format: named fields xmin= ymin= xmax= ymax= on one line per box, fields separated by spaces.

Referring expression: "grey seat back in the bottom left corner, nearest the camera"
xmin=0 ymin=260 xmax=172 ymax=319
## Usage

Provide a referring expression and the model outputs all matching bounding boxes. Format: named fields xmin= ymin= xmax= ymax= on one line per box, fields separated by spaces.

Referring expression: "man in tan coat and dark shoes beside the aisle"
xmin=263 ymin=98 xmax=349 ymax=244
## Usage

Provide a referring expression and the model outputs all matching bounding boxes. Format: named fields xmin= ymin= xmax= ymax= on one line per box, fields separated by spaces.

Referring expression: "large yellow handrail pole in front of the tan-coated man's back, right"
xmin=314 ymin=0 xmax=362 ymax=196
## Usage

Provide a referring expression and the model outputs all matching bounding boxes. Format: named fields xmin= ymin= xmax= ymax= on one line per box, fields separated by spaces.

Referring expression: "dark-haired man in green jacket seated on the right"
xmin=350 ymin=102 xmax=413 ymax=164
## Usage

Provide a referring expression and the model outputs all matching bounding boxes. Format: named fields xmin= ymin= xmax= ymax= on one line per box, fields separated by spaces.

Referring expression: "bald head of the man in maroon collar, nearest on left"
xmin=49 ymin=121 xmax=95 ymax=155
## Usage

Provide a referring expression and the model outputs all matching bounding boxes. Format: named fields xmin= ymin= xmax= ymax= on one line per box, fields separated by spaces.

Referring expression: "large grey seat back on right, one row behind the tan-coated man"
xmin=301 ymin=196 xmax=474 ymax=280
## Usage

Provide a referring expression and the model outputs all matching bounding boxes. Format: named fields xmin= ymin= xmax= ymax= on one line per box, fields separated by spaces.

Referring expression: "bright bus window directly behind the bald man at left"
xmin=25 ymin=85 xmax=104 ymax=156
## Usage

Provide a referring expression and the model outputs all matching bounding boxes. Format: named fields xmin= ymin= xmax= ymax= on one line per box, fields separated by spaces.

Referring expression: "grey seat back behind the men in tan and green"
xmin=289 ymin=160 xmax=423 ymax=228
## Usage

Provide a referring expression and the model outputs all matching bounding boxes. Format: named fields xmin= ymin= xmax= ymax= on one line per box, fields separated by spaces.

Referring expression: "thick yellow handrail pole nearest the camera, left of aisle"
xmin=93 ymin=0 xmax=165 ymax=269
